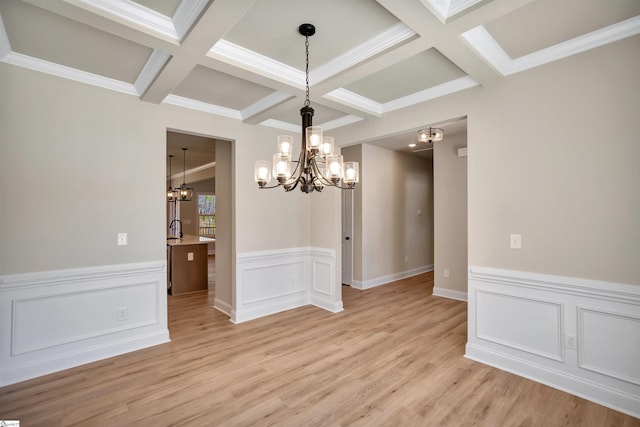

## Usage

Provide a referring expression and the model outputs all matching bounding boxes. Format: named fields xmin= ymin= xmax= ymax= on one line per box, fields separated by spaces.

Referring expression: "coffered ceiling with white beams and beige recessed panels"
xmin=0 ymin=0 xmax=640 ymax=159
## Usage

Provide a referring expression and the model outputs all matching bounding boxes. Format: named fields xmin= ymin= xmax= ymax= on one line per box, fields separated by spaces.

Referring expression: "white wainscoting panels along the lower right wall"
xmin=465 ymin=267 xmax=640 ymax=417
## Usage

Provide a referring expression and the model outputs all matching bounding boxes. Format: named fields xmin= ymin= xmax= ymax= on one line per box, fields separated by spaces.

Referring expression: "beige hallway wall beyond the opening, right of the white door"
xmin=345 ymin=144 xmax=433 ymax=281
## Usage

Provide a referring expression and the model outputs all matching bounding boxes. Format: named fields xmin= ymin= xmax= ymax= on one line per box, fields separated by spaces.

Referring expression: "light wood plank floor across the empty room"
xmin=0 ymin=273 xmax=640 ymax=427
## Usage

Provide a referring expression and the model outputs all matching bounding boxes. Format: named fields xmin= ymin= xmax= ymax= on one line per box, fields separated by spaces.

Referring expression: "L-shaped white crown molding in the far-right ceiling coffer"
xmin=462 ymin=16 xmax=640 ymax=77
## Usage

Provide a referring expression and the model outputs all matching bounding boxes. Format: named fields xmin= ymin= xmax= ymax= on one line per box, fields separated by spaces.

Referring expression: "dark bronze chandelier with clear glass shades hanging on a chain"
xmin=254 ymin=24 xmax=359 ymax=193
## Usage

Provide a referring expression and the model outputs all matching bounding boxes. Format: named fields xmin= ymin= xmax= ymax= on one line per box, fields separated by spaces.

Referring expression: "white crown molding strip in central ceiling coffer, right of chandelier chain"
xmin=309 ymin=22 xmax=416 ymax=84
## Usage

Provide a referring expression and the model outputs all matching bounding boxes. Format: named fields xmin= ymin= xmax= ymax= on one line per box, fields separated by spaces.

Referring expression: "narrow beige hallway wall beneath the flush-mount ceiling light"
xmin=433 ymin=128 xmax=467 ymax=292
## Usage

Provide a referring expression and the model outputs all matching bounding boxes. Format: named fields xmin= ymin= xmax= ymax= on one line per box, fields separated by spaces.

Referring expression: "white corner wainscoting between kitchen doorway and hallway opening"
xmin=231 ymin=247 xmax=342 ymax=323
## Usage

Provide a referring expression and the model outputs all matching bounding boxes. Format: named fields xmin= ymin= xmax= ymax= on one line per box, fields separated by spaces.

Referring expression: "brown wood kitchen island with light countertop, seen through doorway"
xmin=167 ymin=235 xmax=214 ymax=295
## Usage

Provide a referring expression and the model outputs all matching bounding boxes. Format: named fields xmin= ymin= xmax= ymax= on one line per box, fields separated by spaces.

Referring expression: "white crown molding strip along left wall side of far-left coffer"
xmin=0 ymin=52 xmax=138 ymax=96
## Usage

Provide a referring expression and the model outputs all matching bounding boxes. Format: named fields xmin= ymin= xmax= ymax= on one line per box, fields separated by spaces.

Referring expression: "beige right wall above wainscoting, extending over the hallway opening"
xmin=336 ymin=36 xmax=640 ymax=284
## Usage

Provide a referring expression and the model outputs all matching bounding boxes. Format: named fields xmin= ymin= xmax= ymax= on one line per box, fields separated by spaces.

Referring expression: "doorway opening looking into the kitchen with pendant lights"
xmin=165 ymin=129 xmax=232 ymax=330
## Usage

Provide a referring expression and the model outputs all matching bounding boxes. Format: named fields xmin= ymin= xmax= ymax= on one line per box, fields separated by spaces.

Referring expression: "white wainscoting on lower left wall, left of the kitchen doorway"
xmin=0 ymin=261 xmax=169 ymax=386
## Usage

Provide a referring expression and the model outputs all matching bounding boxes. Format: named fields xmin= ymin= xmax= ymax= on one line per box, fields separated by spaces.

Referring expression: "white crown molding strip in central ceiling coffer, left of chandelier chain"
xmin=207 ymin=39 xmax=305 ymax=89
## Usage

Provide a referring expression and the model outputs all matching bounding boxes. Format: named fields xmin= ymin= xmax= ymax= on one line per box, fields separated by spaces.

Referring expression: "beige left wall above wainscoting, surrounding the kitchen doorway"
xmin=0 ymin=64 xmax=312 ymax=284
